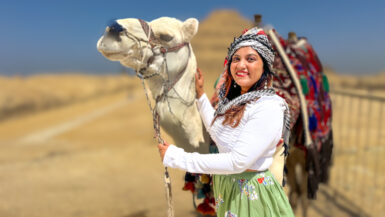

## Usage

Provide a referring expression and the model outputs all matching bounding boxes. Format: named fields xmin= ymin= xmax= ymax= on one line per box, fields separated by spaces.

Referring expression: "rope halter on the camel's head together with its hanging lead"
xmin=129 ymin=19 xmax=195 ymax=217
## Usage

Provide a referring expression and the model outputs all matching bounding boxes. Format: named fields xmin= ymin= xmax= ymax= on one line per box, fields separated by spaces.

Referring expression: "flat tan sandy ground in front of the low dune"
xmin=0 ymin=85 xmax=378 ymax=217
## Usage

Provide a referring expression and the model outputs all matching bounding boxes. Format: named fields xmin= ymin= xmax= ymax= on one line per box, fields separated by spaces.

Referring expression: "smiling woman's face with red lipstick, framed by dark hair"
xmin=230 ymin=47 xmax=263 ymax=94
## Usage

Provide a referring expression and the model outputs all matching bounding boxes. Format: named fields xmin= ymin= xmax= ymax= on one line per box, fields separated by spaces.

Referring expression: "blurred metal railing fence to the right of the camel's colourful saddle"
xmin=328 ymin=90 xmax=385 ymax=216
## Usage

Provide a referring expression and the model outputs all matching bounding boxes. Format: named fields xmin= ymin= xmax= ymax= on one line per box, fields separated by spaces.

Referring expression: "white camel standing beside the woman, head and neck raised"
xmin=97 ymin=17 xmax=284 ymax=183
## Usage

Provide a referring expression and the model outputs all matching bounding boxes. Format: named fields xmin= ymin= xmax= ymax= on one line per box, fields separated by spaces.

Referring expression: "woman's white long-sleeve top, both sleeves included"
xmin=163 ymin=94 xmax=285 ymax=174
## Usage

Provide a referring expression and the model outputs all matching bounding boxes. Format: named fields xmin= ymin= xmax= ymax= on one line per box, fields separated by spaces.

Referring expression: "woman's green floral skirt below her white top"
xmin=213 ymin=170 xmax=294 ymax=217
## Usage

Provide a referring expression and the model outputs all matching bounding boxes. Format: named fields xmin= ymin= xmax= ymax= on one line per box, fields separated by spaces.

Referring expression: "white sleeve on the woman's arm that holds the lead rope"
xmin=163 ymin=101 xmax=283 ymax=174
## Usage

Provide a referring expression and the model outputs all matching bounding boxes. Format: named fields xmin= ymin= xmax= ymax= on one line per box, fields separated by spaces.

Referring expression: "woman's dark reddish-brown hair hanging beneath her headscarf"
xmin=211 ymin=56 xmax=273 ymax=128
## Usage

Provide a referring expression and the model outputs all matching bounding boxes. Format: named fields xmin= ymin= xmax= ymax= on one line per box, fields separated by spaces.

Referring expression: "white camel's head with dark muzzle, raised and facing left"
xmin=97 ymin=17 xmax=198 ymax=70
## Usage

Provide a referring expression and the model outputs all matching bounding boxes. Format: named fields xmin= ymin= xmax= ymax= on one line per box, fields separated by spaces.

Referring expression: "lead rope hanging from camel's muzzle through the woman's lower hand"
xmin=136 ymin=29 xmax=174 ymax=217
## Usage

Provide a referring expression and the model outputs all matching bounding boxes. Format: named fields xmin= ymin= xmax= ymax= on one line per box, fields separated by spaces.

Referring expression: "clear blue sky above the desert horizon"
xmin=0 ymin=0 xmax=385 ymax=75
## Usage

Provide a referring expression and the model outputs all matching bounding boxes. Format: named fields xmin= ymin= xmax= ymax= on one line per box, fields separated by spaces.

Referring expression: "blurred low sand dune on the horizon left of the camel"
xmin=0 ymin=73 xmax=139 ymax=120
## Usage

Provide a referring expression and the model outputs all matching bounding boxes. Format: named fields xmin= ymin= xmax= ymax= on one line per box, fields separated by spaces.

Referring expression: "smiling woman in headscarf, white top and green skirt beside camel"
xmin=158 ymin=28 xmax=294 ymax=217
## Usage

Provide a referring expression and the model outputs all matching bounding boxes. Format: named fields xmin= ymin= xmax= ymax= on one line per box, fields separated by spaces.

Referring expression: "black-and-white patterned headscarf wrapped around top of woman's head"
xmin=227 ymin=27 xmax=274 ymax=68
